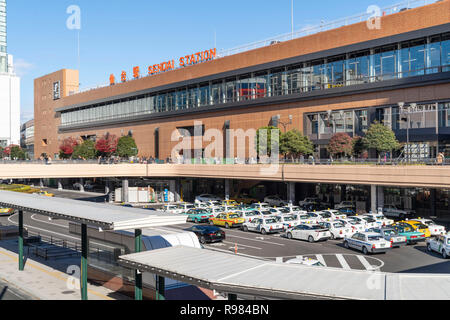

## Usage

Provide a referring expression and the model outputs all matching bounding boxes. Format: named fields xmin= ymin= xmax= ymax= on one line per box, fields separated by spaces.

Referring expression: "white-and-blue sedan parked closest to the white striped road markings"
xmin=344 ymin=232 xmax=392 ymax=255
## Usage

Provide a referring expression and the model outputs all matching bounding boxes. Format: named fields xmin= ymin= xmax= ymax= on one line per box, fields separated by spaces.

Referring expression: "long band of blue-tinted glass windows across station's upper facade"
xmin=61 ymin=33 xmax=450 ymax=126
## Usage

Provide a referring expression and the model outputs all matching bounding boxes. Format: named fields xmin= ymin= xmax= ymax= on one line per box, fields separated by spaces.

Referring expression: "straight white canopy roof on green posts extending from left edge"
xmin=0 ymin=191 xmax=186 ymax=230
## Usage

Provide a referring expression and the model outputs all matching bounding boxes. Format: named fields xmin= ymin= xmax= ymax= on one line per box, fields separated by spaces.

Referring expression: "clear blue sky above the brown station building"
xmin=7 ymin=0 xmax=396 ymax=120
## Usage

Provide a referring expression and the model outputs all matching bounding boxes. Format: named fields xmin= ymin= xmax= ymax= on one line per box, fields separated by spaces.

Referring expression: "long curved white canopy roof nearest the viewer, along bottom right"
xmin=119 ymin=246 xmax=450 ymax=300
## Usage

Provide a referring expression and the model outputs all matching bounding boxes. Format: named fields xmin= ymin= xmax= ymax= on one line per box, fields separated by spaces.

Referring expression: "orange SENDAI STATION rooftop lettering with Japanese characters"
xmin=109 ymin=48 xmax=217 ymax=85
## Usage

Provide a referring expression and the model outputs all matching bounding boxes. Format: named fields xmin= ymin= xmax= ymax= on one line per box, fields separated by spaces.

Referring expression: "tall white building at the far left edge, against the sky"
xmin=0 ymin=0 xmax=20 ymax=147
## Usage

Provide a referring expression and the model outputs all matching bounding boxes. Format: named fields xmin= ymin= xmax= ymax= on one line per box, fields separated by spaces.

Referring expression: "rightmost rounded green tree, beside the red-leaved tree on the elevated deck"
xmin=363 ymin=122 xmax=401 ymax=155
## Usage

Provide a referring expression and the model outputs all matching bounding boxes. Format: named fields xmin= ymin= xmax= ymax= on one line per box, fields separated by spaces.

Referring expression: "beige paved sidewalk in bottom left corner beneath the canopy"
xmin=0 ymin=240 xmax=129 ymax=300
